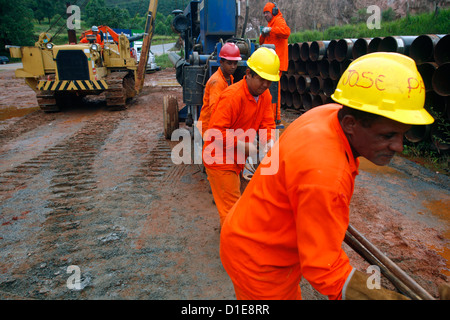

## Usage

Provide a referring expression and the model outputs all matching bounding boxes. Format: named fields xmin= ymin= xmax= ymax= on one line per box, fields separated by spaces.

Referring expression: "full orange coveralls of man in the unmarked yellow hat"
xmin=203 ymin=77 xmax=275 ymax=225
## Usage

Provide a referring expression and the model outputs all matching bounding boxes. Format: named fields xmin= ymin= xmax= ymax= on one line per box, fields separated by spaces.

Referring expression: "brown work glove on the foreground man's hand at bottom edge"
xmin=342 ymin=270 xmax=410 ymax=300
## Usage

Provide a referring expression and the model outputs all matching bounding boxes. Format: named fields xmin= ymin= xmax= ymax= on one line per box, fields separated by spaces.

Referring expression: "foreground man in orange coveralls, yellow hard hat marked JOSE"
xmin=220 ymin=52 xmax=434 ymax=300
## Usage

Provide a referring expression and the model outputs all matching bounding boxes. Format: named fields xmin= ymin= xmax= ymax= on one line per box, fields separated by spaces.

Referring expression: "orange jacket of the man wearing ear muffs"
xmin=259 ymin=3 xmax=291 ymax=71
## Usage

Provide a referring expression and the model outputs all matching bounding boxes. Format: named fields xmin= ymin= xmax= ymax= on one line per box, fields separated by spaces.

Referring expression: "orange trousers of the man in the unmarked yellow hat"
xmin=205 ymin=167 xmax=241 ymax=227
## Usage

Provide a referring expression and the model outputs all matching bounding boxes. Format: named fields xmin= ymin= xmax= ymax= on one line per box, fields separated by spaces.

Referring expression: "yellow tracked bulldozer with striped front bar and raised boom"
xmin=7 ymin=0 xmax=158 ymax=112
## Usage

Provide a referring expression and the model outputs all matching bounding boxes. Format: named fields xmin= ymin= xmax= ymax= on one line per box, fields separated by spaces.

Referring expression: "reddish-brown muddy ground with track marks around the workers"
xmin=0 ymin=69 xmax=450 ymax=300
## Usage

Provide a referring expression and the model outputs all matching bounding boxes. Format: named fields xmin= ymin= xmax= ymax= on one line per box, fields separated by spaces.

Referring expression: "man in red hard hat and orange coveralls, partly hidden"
xmin=197 ymin=42 xmax=242 ymax=137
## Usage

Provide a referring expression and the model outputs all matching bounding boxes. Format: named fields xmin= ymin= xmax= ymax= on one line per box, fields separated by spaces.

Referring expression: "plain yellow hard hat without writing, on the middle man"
xmin=247 ymin=47 xmax=280 ymax=81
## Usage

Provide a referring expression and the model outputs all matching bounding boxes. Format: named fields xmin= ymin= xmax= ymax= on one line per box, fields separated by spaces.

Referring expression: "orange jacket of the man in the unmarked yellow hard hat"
xmin=203 ymin=76 xmax=275 ymax=174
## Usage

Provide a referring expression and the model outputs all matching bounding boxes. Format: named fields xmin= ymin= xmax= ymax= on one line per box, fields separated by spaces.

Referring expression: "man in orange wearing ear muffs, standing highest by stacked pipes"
xmin=259 ymin=2 xmax=291 ymax=123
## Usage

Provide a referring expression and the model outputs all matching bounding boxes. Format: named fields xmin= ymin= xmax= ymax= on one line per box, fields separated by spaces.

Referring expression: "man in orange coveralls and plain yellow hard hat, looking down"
xmin=203 ymin=48 xmax=280 ymax=226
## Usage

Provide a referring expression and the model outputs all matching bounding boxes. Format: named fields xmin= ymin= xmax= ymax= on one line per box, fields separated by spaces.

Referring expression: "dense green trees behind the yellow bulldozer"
xmin=0 ymin=0 xmax=189 ymax=55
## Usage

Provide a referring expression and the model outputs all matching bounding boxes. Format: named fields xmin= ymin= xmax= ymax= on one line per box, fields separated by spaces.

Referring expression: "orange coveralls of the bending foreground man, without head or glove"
xmin=220 ymin=104 xmax=359 ymax=300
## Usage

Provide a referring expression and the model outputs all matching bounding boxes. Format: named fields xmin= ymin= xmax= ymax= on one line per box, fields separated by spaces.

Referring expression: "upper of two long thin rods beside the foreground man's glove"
xmin=347 ymin=225 xmax=435 ymax=300
